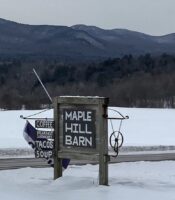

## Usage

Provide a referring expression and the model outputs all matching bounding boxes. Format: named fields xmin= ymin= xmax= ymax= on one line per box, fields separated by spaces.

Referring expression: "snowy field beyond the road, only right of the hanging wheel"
xmin=112 ymin=108 xmax=175 ymax=146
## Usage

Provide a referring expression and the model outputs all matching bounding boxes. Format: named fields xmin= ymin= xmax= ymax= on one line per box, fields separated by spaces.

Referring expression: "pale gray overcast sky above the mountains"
xmin=0 ymin=0 xmax=175 ymax=35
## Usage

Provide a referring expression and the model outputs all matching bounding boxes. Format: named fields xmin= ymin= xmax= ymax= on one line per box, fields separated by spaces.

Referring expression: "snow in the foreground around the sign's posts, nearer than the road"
xmin=0 ymin=161 xmax=175 ymax=200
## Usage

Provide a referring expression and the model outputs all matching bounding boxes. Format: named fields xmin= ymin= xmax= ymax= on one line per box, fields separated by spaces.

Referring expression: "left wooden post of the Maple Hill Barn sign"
xmin=53 ymin=98 xmax=62 ymax=180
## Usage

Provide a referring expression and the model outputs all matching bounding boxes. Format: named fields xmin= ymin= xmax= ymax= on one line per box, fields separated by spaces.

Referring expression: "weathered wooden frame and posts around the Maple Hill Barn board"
xmin=54 ymin=96 xmax=109 ymax=185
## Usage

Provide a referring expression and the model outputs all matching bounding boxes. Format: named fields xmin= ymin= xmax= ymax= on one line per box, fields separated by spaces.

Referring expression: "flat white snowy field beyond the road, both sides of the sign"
xmin=0 ymin=108 xmax=175 ymax=149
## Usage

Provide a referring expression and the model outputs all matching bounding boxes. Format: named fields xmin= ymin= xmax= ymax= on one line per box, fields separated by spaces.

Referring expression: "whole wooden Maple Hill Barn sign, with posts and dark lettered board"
xmin=54 ymin=96 xmax=109 ymax=185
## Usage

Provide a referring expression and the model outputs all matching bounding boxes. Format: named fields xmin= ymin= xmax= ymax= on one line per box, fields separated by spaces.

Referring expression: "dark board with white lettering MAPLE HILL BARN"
xmin=63 ymin=109 xmax=95 ymax=148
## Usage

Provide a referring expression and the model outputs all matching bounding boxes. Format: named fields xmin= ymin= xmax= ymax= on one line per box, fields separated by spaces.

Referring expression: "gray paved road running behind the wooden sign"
xmin=0 ymin=153 xmax=175 ymax=170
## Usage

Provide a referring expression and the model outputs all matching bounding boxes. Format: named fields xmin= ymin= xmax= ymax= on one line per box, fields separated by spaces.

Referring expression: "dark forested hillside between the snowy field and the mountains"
xmin=0 ymin=54 xmax=175 ymax=109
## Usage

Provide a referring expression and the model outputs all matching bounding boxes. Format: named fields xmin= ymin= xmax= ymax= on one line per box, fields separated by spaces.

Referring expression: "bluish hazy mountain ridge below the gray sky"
xmin=0 ymin=18 xmax=175 ymax=60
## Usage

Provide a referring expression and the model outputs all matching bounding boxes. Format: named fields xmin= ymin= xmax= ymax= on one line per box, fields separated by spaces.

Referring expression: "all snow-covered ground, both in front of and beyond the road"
xmin=0 ymin=108 xmax=175 ymax=200
